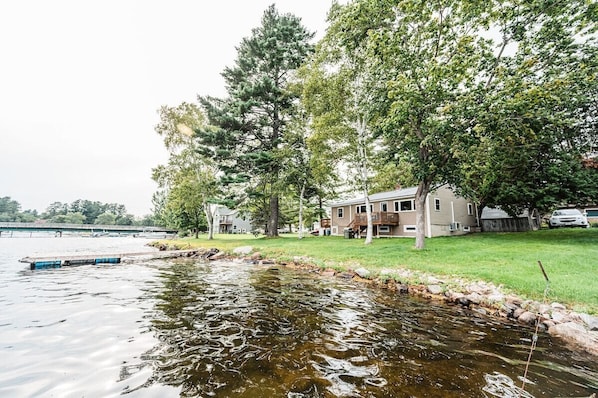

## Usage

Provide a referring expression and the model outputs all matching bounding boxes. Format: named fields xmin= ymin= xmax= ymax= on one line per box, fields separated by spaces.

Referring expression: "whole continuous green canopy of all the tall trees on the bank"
xmin=146 ymin=0 xmax=598 ymax=243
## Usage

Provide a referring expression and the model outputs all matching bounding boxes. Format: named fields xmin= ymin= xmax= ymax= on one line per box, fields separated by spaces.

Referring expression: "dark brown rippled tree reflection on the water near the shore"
xmin=140 ymin=261 xmax=598 ymax=398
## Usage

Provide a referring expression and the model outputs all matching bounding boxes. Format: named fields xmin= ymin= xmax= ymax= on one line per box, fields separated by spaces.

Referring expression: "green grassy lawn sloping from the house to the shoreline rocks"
xmin=166 ymin=228 xmax=598 ymax=313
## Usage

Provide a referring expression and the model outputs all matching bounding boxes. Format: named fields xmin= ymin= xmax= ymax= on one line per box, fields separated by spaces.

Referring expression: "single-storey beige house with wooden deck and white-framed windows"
xmin=330 ymin=186 xmax=477 ymax=237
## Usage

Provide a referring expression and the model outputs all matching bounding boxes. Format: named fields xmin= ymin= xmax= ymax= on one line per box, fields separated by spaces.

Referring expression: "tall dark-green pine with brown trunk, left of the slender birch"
xmin=197 ymin=5 xmax=313 ymax=236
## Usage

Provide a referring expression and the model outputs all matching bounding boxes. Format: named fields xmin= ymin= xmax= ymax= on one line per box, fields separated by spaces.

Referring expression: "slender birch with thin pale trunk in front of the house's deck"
xmin=303 ymin=4 xmax=392 ymax=245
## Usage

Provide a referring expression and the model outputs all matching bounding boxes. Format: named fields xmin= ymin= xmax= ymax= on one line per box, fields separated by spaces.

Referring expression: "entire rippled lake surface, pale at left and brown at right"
xmin=0 ymin=237 xmax=598 ymax=398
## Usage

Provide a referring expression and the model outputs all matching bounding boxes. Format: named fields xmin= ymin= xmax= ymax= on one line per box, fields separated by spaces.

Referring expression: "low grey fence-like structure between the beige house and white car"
xmin=480 ymin=207 xmax=541 ymax=232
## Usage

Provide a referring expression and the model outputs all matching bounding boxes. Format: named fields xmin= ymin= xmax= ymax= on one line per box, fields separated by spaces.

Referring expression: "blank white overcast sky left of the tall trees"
xmin=0 ymin=0 xmax=331 ymax=216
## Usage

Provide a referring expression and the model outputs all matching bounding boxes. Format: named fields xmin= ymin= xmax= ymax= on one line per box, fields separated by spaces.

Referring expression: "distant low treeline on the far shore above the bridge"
xmin=0 ymin=196 xmax=155 ymax=226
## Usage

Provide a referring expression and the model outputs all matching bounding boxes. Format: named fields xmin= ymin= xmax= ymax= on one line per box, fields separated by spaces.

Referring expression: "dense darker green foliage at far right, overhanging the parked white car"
xmin=453 ymin=1 xmax=598 ymax=214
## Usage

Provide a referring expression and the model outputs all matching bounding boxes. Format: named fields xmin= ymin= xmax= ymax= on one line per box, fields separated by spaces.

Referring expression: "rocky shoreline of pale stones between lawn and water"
xmin=152 ymin=246 xmax=598 ymax=357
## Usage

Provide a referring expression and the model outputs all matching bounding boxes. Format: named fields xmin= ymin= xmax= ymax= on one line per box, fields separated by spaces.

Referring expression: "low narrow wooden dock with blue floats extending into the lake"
xmin=19 ymin=249 xmax=201 ymax=270
